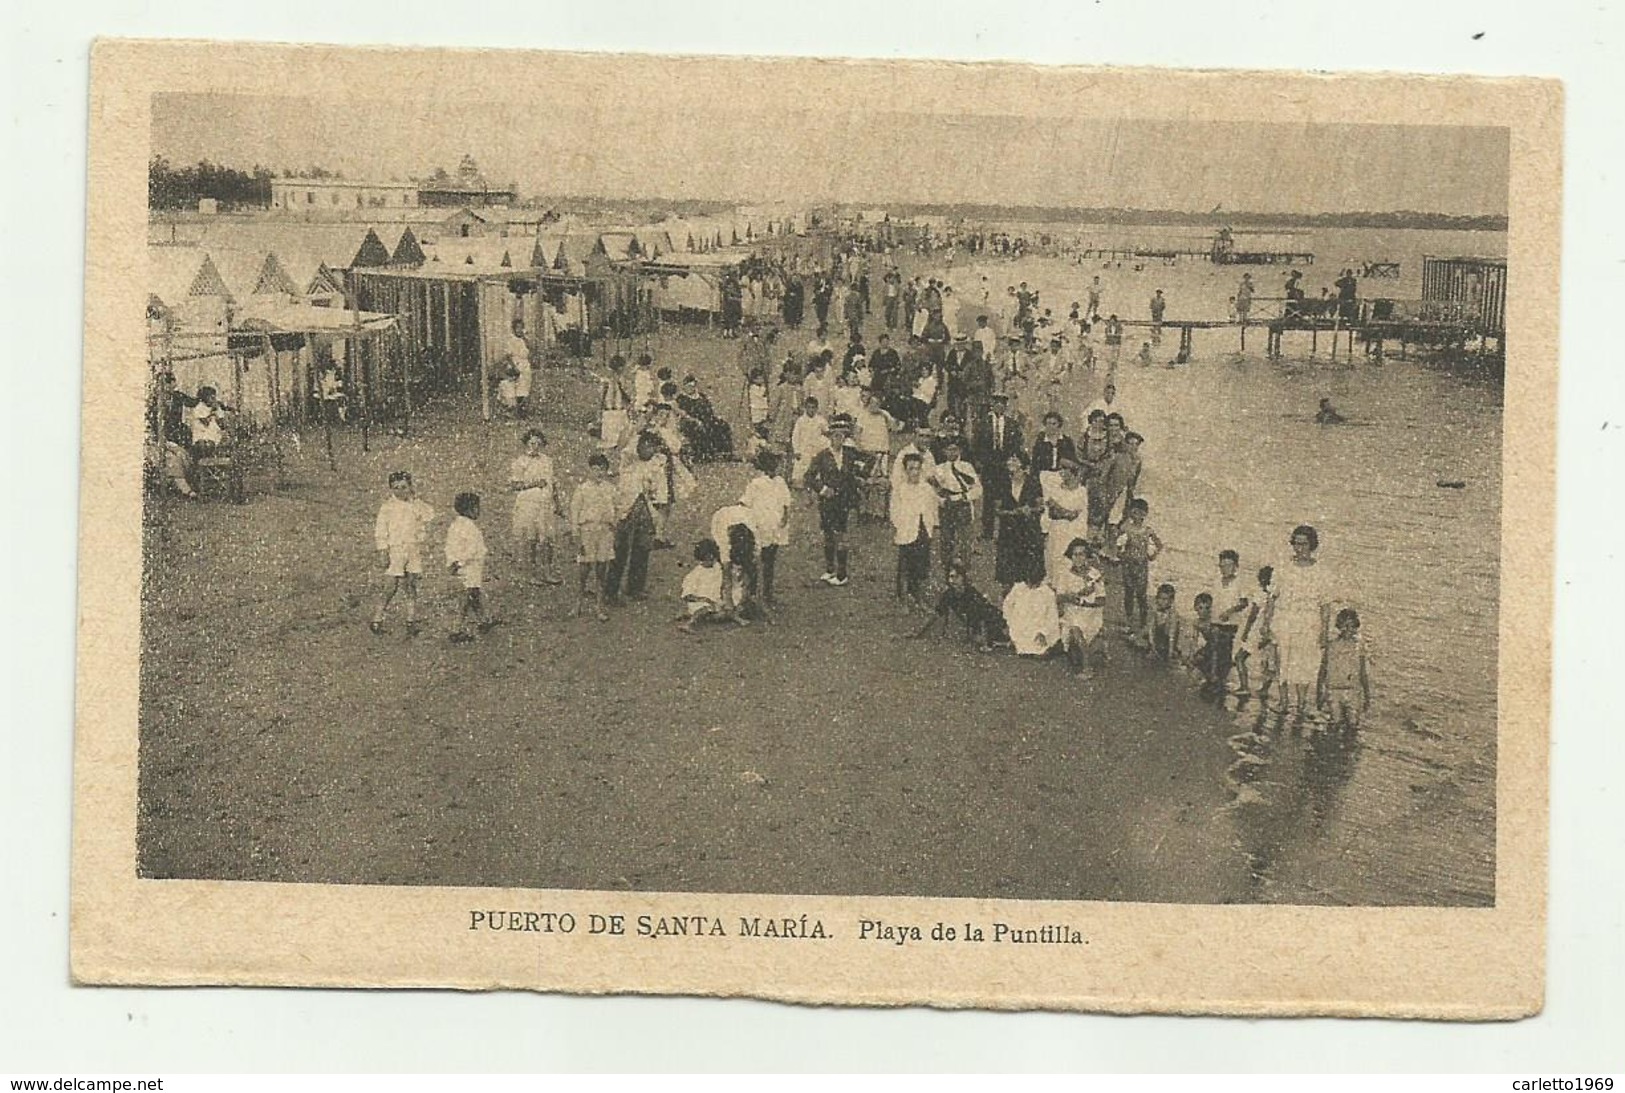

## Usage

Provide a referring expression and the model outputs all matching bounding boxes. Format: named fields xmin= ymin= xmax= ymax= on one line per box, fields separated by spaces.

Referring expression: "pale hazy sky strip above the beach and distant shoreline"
xmin=153 ymin=93 xmax=1508 ymax=216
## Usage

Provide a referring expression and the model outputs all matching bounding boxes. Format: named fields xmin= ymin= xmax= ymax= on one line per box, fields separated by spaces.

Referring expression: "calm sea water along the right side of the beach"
xmin=923 ymin=231 xmax=1505 ymax=903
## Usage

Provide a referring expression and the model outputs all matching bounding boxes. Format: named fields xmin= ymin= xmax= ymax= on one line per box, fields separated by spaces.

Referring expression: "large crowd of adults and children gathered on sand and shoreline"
xmin=359 ymin=238 xmax=1370 ymax=728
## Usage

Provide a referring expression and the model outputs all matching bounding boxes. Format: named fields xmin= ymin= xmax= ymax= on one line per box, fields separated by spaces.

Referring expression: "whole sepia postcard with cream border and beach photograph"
xmin=72 ymin=41 xmax=1563 ymax=1018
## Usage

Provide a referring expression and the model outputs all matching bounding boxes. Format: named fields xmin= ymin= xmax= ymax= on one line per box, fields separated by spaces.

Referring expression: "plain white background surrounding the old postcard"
xmin=0 ymin=0 xmax=1625 ymax=1075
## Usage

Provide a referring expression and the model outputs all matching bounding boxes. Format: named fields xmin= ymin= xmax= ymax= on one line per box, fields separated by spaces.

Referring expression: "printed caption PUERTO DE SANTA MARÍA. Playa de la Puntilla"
xmin=468 ymin=909 xmax=1089 ymax=945
